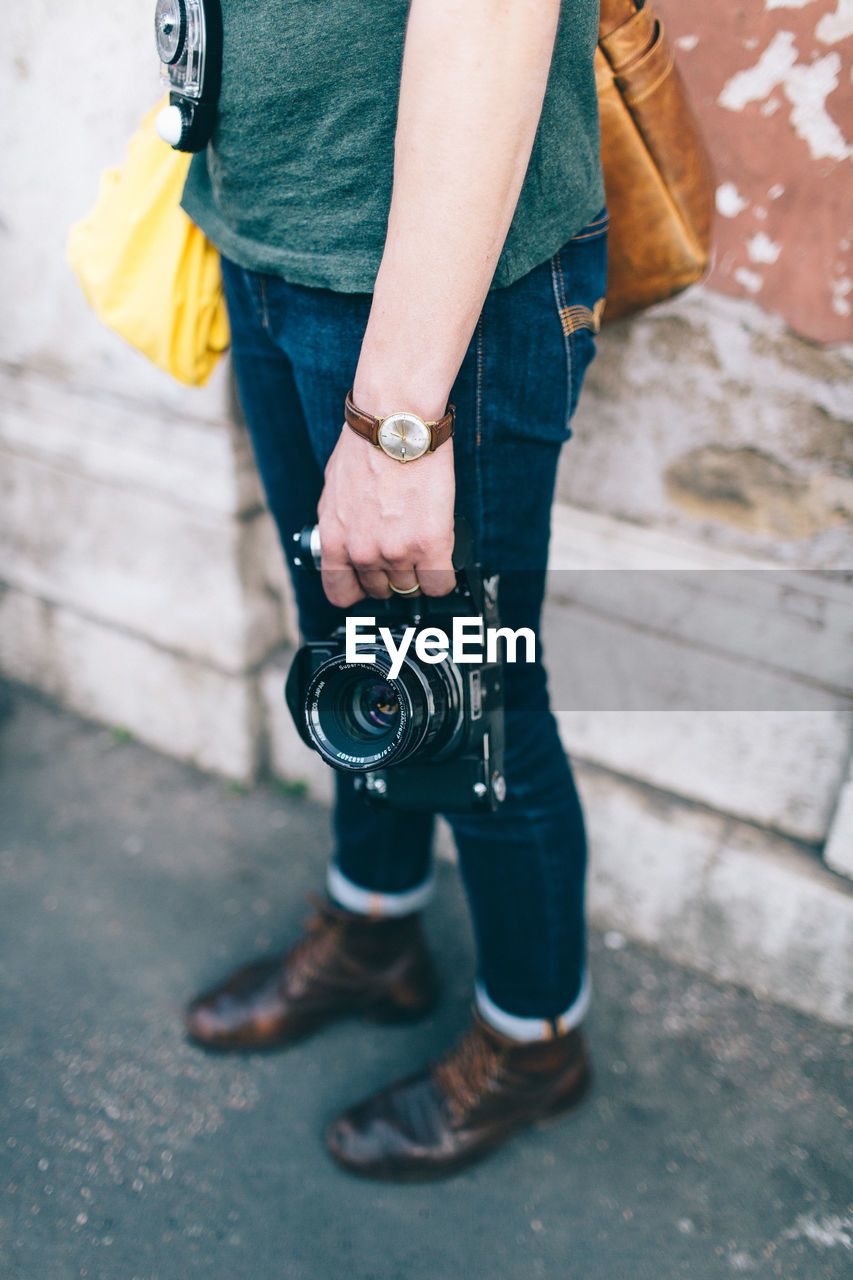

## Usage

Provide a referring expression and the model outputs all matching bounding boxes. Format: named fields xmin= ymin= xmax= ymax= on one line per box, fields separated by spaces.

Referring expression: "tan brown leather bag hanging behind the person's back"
xmin=596 ymin=0 xmax=715 ymax=320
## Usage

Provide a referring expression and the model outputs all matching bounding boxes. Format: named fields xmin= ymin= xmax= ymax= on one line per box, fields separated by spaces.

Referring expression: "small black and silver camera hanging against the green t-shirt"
xmin=154 ymin=0 xmax=222 ymax=151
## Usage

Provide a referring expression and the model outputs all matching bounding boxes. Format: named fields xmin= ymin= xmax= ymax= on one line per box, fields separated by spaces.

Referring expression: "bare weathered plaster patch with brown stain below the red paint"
xmin=558 ymin=288 xmax=853 ymax=570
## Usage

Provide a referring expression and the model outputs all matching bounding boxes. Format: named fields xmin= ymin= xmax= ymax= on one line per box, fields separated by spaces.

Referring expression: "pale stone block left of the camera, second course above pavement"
xmin=0 ymin=453 xmax=284 ymax=672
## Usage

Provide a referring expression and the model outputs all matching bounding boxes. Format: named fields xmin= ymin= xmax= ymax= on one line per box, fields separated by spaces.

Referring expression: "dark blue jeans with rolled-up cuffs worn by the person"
xmin=223 ymin=214 xmax=607 ymax=1024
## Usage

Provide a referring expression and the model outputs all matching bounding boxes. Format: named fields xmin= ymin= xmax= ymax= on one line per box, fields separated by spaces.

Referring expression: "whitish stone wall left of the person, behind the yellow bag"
xmin=0 ymin=0 xmax=287 ymax=780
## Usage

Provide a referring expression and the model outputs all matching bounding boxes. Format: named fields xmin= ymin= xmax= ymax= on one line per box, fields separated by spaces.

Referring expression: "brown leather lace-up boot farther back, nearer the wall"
xmin=186 ymin=900 xmax=437 ymax=1050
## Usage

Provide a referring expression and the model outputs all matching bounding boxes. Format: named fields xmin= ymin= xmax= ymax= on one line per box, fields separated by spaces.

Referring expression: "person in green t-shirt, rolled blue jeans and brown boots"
xmin=184 ymin=0 xmax=606 ymax=1178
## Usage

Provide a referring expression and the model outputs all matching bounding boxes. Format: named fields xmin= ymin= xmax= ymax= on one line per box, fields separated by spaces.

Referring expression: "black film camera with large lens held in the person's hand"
xmin=286 ymin=520 xmax=506 ymax=813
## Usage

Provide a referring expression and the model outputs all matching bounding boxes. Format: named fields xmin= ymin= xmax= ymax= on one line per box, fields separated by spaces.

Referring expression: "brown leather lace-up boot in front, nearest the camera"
xmin=325 ymin=1012 xmax=589 ymax=1181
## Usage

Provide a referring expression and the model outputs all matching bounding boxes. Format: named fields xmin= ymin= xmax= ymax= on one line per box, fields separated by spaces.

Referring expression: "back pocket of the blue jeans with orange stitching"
xmin=551 ymin=211 xmax=607 ymax=434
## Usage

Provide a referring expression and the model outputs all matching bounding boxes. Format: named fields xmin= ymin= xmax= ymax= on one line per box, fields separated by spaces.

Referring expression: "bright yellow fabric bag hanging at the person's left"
xmin=68 ymin=100 xmax=231 ymax=387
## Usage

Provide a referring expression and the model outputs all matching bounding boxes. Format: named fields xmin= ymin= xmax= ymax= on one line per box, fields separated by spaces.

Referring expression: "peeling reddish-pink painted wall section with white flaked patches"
xmin=657 ymin=0 xmax=853 ymax=343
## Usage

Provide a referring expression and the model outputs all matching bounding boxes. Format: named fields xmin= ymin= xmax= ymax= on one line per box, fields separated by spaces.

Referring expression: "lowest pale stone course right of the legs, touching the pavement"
xmin=576 ymin=765 xmax=853 ymax=1025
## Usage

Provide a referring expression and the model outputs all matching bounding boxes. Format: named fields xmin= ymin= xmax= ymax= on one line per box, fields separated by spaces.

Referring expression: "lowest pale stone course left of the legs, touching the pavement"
xmin=0 ymin=588 xmax=260 ymax=773
